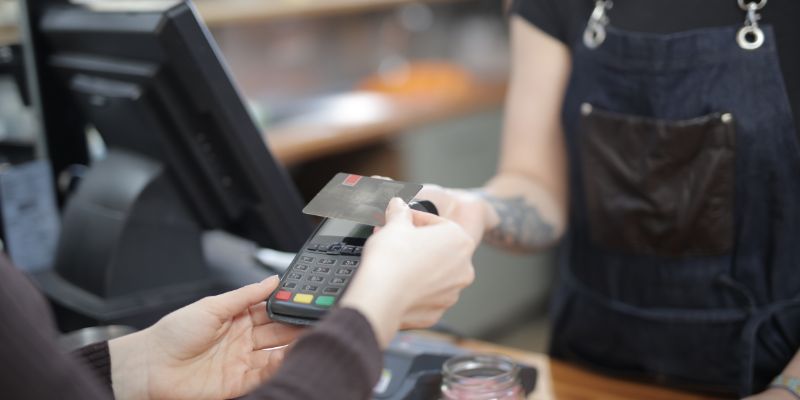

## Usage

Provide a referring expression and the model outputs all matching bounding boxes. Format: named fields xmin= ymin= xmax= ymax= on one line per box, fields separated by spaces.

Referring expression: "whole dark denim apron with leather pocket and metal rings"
xmin=551 ymin=2 xmax=800 ymax=395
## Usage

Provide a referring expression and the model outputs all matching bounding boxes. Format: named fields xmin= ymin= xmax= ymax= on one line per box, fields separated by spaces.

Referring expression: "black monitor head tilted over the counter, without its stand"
xmin=40 ymin=1 xmax=311 ymax=250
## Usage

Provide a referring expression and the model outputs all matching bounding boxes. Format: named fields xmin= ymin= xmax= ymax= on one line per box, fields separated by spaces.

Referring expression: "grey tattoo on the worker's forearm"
xmin=481 ymin=192 xmax=557 ymax=250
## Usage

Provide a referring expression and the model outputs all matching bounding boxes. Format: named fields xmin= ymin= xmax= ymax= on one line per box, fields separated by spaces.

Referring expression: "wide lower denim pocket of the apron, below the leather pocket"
xmin=551 ymin=293 xmax=747 ymax=395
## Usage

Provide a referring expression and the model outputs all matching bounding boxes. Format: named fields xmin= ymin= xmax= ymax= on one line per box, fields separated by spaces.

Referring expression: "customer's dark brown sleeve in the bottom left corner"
xmin=0 ymin=255 xmax=112 ymax=400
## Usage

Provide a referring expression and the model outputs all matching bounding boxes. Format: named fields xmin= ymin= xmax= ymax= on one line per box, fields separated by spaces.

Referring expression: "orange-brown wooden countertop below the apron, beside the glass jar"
xmin=457 ymin=340 xmax=714 ymax=400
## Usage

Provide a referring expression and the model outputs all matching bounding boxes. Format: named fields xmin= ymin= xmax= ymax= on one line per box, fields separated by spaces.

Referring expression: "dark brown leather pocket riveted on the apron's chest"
xmin=581 ymin=104 xmax=735 ymax=257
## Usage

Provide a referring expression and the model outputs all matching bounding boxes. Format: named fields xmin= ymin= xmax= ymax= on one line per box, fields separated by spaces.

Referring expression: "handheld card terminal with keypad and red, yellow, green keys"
xmin=267 ymin=200 xmax=438 ymax=325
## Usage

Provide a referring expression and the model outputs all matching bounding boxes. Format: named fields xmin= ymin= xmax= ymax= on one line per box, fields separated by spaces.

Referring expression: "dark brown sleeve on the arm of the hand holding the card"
xmin=247 ymin=308 xmax=382 ymax=400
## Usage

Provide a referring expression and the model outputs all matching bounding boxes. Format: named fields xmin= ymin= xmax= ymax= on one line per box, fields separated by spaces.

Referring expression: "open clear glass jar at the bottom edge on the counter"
xmin=442 ymin=354 xmax=525 ymax=400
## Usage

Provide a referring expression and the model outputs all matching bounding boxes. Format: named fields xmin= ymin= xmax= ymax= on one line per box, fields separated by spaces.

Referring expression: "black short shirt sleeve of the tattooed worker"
xmin=511 ymin=0 xmax=594 ymax=45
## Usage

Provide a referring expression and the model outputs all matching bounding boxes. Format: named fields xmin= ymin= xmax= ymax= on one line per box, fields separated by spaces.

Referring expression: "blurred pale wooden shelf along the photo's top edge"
xmin=195 ymin=0 xmax=464 ymax=27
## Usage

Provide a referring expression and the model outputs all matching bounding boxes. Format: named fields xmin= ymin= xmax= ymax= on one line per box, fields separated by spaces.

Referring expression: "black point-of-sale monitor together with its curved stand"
xmin=24 ymin=0 xmax=311 ymax=330
